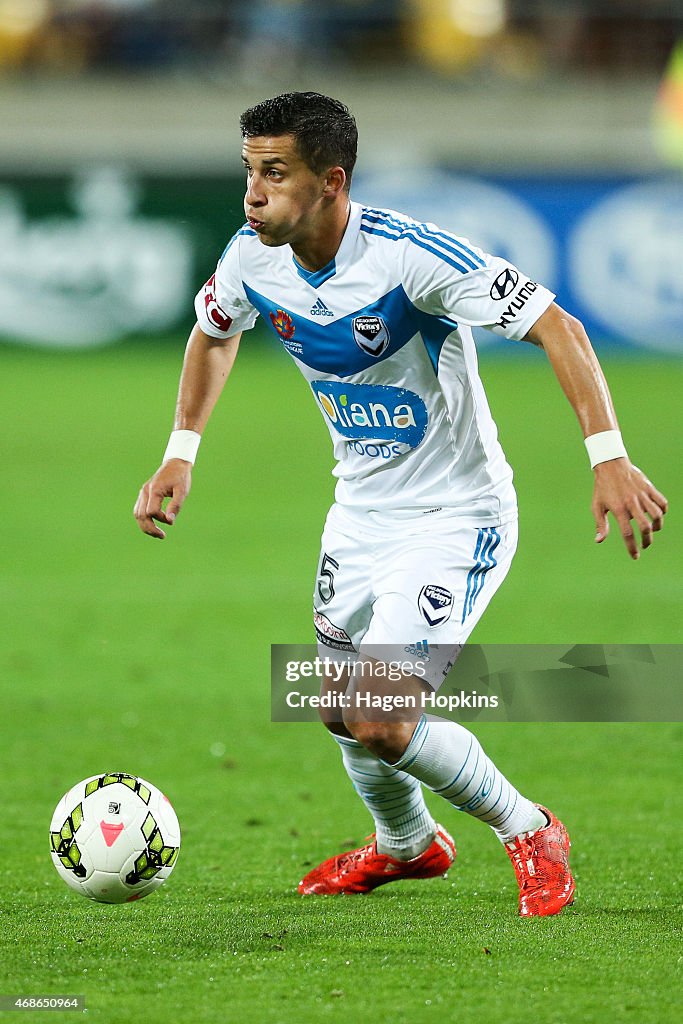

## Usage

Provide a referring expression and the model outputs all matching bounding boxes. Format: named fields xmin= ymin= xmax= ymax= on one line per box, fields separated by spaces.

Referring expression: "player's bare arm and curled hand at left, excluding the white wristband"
xmin=133 ymin=325 xmax=241 ymax=541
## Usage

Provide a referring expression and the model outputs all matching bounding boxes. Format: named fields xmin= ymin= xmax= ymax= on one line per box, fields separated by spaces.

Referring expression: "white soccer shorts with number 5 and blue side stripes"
xmin=313 ymin=505 xmax=517 ymax=690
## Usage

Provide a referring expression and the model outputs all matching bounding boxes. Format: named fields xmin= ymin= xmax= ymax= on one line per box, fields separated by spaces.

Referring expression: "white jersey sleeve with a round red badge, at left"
xmin=195 ymin=231 xmax=258 ymax=338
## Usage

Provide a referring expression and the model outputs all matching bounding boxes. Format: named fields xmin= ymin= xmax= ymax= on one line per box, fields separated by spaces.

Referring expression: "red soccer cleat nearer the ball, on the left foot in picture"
xmin=299 ymin=825 xmax=456 ymax=896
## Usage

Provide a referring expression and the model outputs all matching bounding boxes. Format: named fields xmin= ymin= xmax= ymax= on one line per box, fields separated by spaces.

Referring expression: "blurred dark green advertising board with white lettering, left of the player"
xmin=0 ymin=166 xmax=244 ymax=348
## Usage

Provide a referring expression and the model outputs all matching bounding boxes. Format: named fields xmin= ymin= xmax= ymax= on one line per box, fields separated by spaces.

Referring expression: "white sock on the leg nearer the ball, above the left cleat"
xmin=332 ymin=733 xmax=436 ymax=860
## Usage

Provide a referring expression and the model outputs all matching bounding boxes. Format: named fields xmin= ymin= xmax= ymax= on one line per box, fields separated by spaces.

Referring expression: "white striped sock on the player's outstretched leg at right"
xmin=392 ymin=716 xmax=547 ymax=843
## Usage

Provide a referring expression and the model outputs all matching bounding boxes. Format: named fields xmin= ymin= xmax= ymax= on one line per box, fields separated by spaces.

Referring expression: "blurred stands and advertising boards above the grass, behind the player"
xmin=0 ymin=0 xmax=683 ymax=353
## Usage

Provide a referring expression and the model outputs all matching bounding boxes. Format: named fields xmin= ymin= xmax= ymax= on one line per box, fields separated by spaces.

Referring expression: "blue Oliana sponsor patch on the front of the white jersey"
xmin=310 ymin=381 xmax=429 ymax=454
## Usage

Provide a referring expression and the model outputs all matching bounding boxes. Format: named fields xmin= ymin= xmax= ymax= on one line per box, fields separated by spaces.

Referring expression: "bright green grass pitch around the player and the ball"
xmin=0 ymin=338 xmax=683 ymax=1024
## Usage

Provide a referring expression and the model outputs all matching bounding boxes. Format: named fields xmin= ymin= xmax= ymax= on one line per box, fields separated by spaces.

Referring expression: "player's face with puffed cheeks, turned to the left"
xmin=242 ymin=135 xmax=326 ymax=246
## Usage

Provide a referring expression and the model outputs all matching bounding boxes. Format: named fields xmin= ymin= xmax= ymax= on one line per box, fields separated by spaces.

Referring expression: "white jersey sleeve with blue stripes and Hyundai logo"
xmin=402 ymin=224 xmax=555 ymax=341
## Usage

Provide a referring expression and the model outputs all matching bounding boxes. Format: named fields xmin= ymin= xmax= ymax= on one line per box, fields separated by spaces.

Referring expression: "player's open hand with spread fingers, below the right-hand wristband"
xmin=592 ymin=459 xmax=669 ymax=558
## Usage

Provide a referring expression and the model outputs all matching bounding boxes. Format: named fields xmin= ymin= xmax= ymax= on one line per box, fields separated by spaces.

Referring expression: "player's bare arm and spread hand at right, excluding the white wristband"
xmin=528 ymin=303 xmax=668 ymax=558
